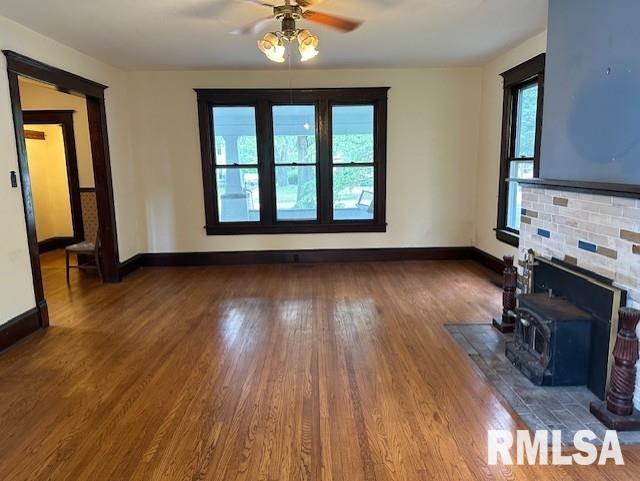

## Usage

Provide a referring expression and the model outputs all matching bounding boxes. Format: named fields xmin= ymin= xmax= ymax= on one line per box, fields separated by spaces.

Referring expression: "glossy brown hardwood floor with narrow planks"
xmin=0 ymin=253 xmax=640 ymax=481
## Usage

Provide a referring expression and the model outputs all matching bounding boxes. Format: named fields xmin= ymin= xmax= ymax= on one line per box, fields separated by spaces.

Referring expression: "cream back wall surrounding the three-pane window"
xmin=131 ymin=68 xmax=481 ymax=252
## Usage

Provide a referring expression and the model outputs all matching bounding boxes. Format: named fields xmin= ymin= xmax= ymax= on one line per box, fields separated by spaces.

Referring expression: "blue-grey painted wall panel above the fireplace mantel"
xmin=540 ymin=0 xmax=640 ymax=184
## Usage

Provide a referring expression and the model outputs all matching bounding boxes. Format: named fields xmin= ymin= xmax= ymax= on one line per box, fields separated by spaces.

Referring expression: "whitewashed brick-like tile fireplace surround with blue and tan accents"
xmin=519 ymin=184 xmax=640 ymax=409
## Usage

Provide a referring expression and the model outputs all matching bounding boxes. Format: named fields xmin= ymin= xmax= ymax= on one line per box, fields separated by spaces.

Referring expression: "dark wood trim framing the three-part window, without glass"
xmin=195 ymin=87 xmax=389 ymax=235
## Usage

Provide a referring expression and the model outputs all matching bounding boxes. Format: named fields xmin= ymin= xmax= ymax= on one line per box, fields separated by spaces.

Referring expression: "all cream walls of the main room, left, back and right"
xmin=0 ymin=9 xmax=545 ymax=323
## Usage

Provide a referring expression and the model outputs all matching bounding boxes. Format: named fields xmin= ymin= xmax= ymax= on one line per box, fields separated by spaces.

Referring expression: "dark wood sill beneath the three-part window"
xmin=205 ymin=222 xmax=387 ymax=235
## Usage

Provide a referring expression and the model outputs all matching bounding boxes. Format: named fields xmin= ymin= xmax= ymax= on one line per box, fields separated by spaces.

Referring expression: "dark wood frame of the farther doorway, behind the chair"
xmin=22 ymin=110 xmax=84 ymax=252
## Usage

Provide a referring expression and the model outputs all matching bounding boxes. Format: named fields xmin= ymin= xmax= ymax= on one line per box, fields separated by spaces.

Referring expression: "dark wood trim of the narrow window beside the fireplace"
xmin=495 ymin=53 xmax=546 ymax=247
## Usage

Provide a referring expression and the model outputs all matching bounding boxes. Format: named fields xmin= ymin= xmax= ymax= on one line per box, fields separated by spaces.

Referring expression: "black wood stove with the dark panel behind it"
xmin=506 ymin=252 xmax=626 ymax=399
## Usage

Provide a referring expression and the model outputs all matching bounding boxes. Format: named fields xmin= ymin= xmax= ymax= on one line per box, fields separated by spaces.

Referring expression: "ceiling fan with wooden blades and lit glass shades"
xmin=231 ymin=0 xmax=362 ymax=63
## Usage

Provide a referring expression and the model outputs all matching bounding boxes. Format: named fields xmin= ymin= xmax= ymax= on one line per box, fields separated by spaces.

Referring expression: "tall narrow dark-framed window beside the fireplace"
xmin=496 ymin=54 xmax=545 ymax=246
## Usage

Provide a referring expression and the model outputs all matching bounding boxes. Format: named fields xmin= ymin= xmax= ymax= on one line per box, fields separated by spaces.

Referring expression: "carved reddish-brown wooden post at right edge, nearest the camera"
xmin=591 ymin=307 xmax=640 ymax=431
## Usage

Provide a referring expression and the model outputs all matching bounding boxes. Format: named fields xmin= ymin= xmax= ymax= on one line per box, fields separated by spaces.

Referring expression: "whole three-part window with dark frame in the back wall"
xmin=196 ymin=88 xmax=388 ymax=235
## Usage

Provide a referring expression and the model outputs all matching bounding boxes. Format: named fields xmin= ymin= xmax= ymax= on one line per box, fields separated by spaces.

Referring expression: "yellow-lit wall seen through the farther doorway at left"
xmin=26 ymin=125 xmax=73 ymax=241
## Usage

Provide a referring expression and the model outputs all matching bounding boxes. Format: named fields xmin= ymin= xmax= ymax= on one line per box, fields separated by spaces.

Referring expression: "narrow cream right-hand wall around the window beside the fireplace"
xmin=474 ymin=32 xmax=547 ymax=257
